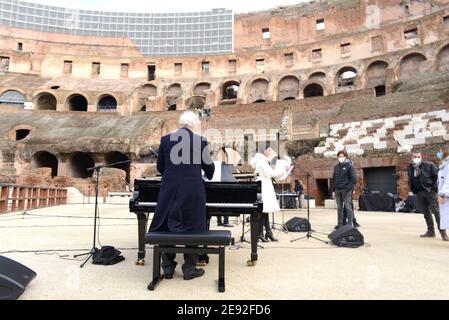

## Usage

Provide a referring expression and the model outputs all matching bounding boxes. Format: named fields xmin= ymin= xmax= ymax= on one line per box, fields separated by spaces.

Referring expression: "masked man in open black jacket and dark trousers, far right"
xmin=407 ymin=152 xmax=449 ymax=241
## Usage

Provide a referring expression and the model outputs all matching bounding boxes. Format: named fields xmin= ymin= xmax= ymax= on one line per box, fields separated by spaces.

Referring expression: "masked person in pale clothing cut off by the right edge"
xmin=437 ymin=147 xmax=449 ymax=230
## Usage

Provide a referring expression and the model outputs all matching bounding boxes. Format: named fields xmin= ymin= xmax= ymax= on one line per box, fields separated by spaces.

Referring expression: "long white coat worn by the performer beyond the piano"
xmin=251 ymin=153 xmax=285 ymax=213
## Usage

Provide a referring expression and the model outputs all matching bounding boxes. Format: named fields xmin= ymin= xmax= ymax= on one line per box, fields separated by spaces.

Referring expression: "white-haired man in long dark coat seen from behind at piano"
xmin=149 ymin=111 xmax=215 ymax=280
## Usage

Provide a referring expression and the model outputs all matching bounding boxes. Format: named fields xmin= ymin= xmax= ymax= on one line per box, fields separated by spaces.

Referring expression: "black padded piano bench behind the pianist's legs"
xmin=145 ymin=230 xmax=234 ymax=292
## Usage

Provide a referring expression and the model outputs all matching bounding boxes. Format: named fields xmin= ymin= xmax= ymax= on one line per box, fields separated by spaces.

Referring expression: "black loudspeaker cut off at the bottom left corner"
xmin=0 ymin=256 xmax=36 ymax=300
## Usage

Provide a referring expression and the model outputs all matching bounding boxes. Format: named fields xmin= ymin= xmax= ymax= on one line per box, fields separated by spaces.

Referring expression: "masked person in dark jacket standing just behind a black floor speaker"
xmin=332 ymin=150 xmax=357 ymax=229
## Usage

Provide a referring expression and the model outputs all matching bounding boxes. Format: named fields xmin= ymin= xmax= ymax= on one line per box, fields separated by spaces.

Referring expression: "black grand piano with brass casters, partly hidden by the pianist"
xmin=129 ymin=179 xmax=263 ymax=266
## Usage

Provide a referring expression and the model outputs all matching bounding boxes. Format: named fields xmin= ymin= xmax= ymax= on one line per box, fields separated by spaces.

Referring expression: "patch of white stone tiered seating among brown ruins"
xmin=314 ymin=110 xmax=449 ymax=157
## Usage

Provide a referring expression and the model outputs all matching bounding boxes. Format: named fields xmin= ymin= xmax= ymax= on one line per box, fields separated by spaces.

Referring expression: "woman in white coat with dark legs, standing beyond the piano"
xmin=251 ymin=148 xmax=289 ymax=242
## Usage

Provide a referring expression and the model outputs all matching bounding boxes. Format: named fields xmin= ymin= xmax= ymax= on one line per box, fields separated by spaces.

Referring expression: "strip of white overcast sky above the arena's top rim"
xmin=27 ymin=0 xmax=307 ymax=13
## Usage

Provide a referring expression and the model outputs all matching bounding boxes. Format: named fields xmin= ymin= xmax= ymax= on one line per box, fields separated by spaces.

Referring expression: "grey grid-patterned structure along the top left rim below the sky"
xmin=0 ymin=0 xmax=234 ymax=56
